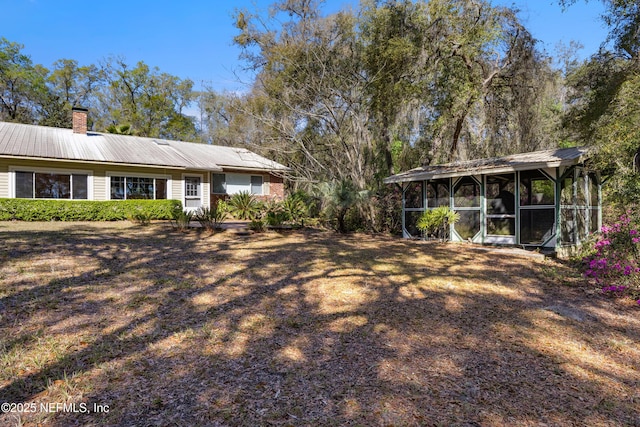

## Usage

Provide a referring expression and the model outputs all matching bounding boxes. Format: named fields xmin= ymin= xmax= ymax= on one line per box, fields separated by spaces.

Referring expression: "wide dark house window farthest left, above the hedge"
xmin=15 ymin=171 xmax=89 ymax=200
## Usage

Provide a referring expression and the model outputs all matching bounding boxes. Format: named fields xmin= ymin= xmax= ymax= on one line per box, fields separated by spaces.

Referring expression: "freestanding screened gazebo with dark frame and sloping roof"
xmin=385 ymin=148 xmax=602 ymax=256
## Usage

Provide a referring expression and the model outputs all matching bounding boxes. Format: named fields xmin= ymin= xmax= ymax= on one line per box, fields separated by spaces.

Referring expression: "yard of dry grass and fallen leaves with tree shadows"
xmin=0 ymin=223 xmax=640 ymax=426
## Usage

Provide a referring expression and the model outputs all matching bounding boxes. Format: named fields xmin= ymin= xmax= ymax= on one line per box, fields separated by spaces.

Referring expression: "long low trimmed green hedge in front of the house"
xmin=0 ymin=199 xmax=182 ymax=221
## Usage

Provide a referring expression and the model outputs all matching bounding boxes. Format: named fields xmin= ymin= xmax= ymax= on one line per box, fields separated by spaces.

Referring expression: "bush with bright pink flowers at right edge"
xmin=583 ymin=212 xmax=640 ymax=304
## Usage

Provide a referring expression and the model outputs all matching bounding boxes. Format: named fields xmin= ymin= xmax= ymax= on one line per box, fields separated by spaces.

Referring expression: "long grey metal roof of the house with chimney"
xmin=0 ymin=122 xmax=288 ymax=171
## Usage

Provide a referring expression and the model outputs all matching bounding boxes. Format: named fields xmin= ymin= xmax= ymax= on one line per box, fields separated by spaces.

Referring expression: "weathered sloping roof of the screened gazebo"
xmin=384 ymin=147 xmax=588 ymax=184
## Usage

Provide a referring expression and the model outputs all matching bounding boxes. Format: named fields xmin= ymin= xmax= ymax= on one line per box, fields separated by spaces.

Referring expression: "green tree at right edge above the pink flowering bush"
xmin=561 ymin=0 xmax=640 ymax=214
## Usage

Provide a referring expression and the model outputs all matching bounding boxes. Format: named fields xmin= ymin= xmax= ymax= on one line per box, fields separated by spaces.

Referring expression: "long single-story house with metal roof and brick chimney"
xmin=0 ymin=109 xmax=288 ymax=210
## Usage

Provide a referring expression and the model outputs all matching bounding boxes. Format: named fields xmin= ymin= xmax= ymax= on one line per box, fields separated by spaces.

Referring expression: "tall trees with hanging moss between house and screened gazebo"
xmin=232 ymin=0 xmax=563 ymax=230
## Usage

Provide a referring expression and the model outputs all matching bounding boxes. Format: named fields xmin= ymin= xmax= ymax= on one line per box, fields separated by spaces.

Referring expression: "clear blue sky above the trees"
xmin=0 ymin=0 xmax=607 ymax=92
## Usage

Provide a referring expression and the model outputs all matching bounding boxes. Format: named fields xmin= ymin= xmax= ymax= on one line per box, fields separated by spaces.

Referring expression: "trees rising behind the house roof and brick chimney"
xmin=0 ymin=38 xmax=197 ymax=141
